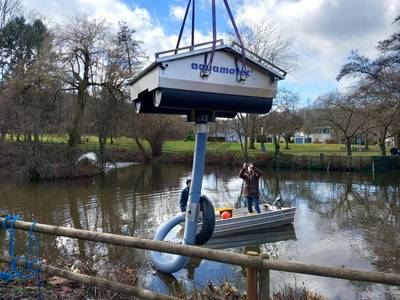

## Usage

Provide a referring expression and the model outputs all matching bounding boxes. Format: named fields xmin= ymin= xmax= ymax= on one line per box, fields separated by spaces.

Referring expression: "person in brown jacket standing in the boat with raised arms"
xmin=239 ymin=163 xmax=261 ymax=214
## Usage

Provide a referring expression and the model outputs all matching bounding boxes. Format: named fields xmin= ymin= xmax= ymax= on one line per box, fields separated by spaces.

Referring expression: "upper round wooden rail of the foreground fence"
xmin=0 ymin=218 xmax=400 ymax=286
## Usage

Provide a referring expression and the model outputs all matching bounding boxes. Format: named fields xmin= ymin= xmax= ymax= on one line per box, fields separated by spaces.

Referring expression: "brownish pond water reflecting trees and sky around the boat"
xmin=0 ymin=164 xmax=400 ymax=299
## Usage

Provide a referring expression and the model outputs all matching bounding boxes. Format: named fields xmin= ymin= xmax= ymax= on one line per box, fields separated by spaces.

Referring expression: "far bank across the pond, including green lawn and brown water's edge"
xmin=0 ymin=136 xmax=400 ymax=179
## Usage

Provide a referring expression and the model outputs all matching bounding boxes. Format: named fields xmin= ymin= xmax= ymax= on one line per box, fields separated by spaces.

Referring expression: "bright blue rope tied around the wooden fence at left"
xmin=0 ymin=214 xmax=42 ymax=300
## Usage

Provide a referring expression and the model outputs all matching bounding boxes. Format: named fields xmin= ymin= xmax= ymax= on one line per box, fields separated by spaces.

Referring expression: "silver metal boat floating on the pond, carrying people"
xmin=212 ymin=205 xmax=296 ymax=237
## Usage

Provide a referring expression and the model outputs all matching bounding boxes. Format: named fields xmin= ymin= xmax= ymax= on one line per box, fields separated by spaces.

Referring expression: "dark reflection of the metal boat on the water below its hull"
xmin=205 ymin=224 xmax=296 ymax=249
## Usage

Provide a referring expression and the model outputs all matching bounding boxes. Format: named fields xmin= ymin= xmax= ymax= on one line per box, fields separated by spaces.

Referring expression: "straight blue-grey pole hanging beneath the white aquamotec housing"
xmin=183 ymin=123 xmax=208 ymax=245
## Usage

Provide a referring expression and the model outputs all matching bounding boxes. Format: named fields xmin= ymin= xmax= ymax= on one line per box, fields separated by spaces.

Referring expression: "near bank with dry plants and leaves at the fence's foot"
xmin=0 ymin=263 xmax=325 ymax=300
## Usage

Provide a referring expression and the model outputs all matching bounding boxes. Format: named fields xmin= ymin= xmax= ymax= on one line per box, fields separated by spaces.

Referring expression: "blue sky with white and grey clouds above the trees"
xmin=22 ymin=0 xmax=400 ymax=105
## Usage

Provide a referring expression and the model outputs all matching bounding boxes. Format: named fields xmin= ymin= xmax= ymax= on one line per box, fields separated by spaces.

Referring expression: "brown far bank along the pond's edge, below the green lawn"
xmin=0 ymin=142 xmax=400 ymax=180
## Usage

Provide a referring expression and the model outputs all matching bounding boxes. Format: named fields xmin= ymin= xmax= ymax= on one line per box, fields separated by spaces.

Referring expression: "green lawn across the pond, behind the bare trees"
xmin=4 ymin=135 xmax=380 ymax=156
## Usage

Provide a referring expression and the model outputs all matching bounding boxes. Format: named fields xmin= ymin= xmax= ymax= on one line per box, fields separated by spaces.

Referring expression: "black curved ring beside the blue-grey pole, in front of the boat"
xmin=195 ymin=196 xmax=215 ymax=245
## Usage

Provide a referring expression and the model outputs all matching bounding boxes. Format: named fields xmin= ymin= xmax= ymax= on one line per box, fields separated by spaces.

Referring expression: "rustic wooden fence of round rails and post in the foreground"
xmin=0 ymin=218 xmax=400 ymax=300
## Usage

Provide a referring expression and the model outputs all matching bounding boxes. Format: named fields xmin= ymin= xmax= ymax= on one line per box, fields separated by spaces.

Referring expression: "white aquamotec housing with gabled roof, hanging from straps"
xmin=128 ymin=40 xmax=286 ymax=118
